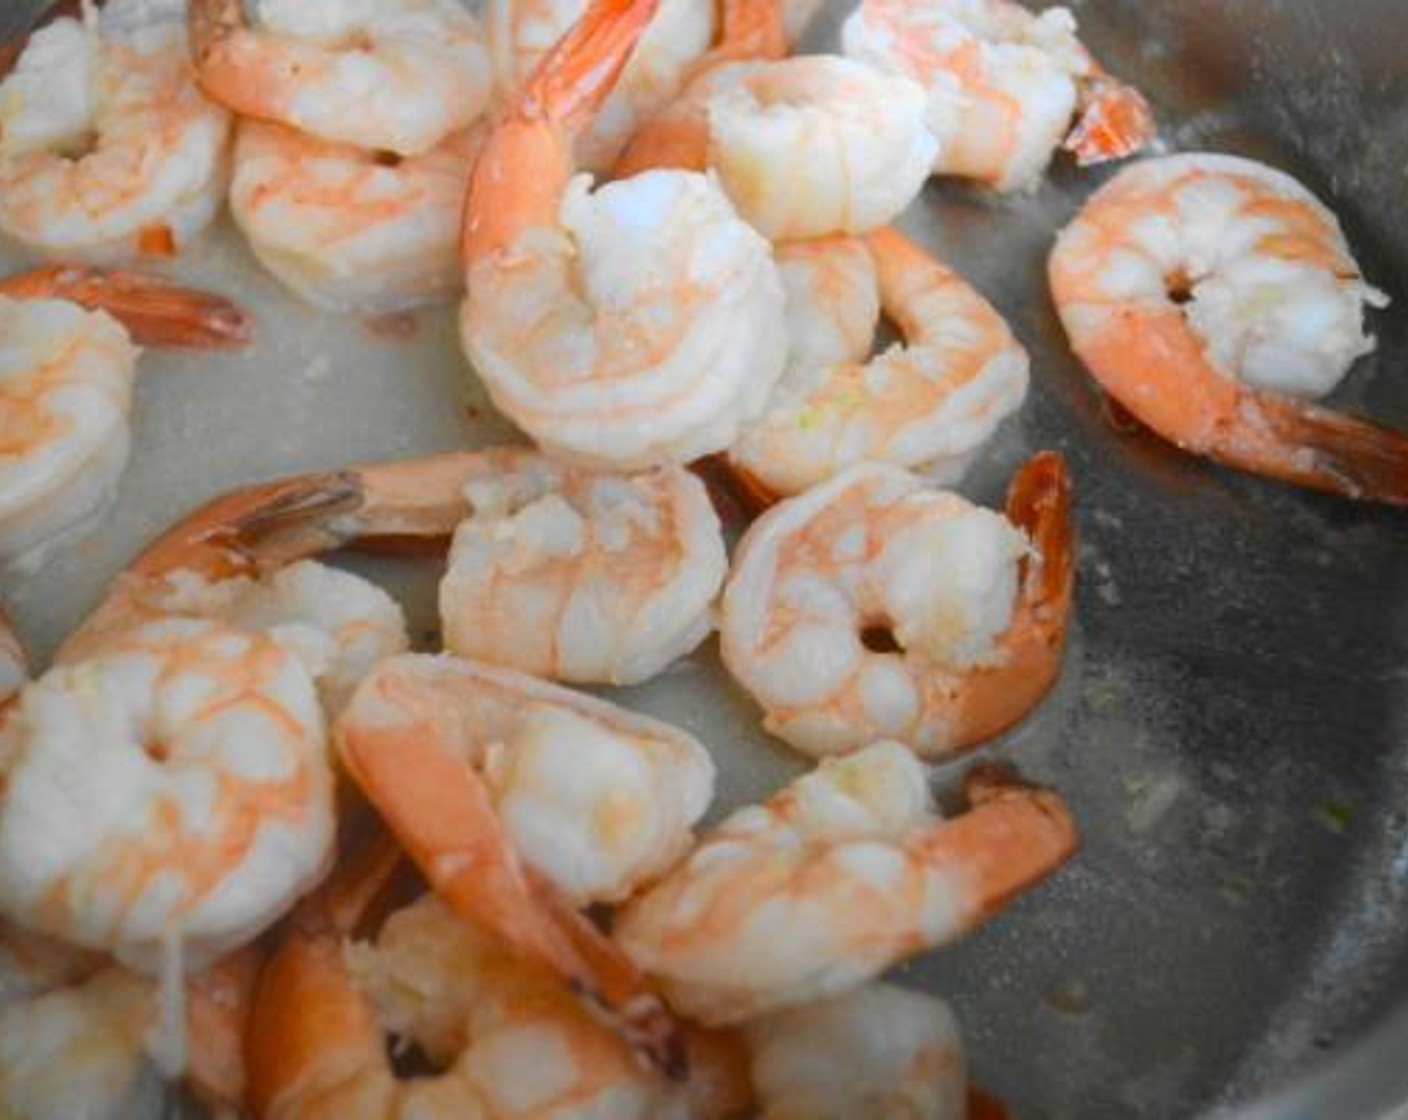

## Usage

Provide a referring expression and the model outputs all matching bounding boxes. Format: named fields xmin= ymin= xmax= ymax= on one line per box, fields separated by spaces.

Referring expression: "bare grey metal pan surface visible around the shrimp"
xmin=0 ymin=0 xmax=1408 ymax=1120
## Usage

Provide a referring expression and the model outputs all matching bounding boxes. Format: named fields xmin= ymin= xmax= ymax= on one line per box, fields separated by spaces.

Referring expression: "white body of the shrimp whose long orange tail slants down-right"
xmin=337 ymin=655 xmax=714 ymax=904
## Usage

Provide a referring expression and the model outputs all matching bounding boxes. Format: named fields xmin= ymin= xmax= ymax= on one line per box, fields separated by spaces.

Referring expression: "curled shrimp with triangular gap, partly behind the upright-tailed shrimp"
xmin=729 ymin=228 xmax=1028 ymax=494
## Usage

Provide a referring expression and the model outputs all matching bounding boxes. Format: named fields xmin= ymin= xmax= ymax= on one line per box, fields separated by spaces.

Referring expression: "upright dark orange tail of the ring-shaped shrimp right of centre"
xmin=955 ymin=451 xmax=1076 ymax=749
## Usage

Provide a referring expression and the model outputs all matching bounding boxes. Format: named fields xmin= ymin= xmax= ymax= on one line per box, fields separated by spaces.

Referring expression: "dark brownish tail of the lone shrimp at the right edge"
xmin=1250 ymin=393 xmax=1408 ymax=506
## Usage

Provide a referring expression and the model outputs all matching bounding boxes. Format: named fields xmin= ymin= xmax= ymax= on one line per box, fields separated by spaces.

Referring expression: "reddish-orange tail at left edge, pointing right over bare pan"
xmin=0 ymin=265 xmax=253 ymax=349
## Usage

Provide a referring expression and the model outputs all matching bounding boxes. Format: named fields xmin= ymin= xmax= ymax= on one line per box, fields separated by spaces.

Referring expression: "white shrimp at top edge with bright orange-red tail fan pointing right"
xmin=841 ymin=0 xmax=1155 ymax=190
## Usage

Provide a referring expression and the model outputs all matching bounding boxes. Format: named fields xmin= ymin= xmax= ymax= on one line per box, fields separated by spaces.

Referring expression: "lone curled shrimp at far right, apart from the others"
xmin=1049 ymin=155 xmax=1408 ymax=504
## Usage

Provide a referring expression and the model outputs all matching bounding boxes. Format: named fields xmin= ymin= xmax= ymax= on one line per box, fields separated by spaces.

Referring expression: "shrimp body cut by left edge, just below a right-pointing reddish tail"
xmin=0 ymin=296 xmax=138 ymax=559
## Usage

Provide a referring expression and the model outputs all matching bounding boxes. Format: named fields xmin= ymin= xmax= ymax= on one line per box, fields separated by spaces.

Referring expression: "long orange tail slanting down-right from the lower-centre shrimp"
xmin=337 ymin=673 xmax=687 ymax=1079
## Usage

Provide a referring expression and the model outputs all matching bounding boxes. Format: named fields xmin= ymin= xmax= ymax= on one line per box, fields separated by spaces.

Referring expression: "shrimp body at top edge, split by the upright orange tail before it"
xmin=484 ymin=0 xmax=714 ymax=172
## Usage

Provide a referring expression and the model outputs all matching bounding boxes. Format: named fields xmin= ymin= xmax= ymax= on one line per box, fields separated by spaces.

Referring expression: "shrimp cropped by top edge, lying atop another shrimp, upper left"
xmin=190 ymin=0 xmax=490 ymax=155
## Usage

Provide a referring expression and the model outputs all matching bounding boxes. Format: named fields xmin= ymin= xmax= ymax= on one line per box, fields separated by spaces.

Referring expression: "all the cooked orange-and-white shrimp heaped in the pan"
xmin=0 ymin=0 xmax=1408 ymax=1120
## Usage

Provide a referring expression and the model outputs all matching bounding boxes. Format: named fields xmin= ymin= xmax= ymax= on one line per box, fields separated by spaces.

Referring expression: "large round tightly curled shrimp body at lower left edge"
xmin=0 ymin=620 xmax=332 ymax=971
